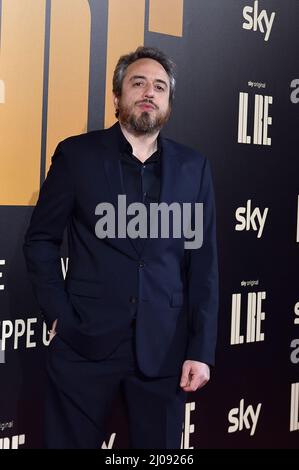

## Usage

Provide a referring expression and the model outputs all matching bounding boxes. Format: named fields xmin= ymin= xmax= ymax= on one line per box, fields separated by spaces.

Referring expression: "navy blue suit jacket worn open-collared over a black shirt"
xmin=24 ymin=123 xmax=218 ymax=377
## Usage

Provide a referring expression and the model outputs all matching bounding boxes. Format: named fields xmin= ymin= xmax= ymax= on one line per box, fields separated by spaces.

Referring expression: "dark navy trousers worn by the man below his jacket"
xmin=44 ymin=327 xmax=186 ymax=449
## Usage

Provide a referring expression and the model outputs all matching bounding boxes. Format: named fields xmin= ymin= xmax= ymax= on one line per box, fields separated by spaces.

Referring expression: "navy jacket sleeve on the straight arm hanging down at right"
xmin=186 ymin=159 xmax=218 ymax=365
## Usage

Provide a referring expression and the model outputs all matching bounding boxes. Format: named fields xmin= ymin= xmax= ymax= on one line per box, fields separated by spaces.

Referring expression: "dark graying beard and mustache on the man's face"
xmin=118 ymin=99 xmax=171 ymax=135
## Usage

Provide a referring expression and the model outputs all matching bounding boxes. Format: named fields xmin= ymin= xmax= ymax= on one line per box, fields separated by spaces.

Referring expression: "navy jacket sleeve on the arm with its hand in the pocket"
xmin=23 ymin=143 xmax=74 ymax=328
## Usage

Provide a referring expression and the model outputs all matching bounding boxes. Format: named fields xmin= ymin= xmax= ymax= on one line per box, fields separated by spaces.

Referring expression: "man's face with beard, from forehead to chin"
xmin=114 ymin=59 xmax=170 ymax=135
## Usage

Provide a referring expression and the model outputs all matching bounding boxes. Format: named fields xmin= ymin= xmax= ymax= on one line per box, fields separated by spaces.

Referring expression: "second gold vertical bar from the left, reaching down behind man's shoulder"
xmin=47 ymin=0 xmax=91 ymax=173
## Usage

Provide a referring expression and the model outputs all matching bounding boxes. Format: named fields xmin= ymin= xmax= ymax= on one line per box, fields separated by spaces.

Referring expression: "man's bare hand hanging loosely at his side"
xmin=180 ymin=360 xmax=210 ymax=392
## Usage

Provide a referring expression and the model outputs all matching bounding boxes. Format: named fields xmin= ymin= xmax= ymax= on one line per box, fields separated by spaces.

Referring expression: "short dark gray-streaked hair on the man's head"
xmin=113 ymin=46 xmax=176 ymax=104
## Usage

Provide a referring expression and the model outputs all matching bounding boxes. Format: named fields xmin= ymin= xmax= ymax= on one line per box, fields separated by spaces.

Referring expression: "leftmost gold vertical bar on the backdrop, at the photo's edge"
xmin=0 ymin=0 xmax=45 ymax=206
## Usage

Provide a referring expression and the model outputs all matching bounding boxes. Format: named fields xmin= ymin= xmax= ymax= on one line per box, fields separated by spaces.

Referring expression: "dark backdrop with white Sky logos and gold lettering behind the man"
xmin=0 ymin=0 xmax=299 ymax=449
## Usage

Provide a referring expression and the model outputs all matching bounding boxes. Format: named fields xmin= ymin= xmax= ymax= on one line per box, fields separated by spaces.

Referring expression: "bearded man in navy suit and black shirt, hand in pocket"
xmin=24 ymin=47 xmax=218 ymax=449
